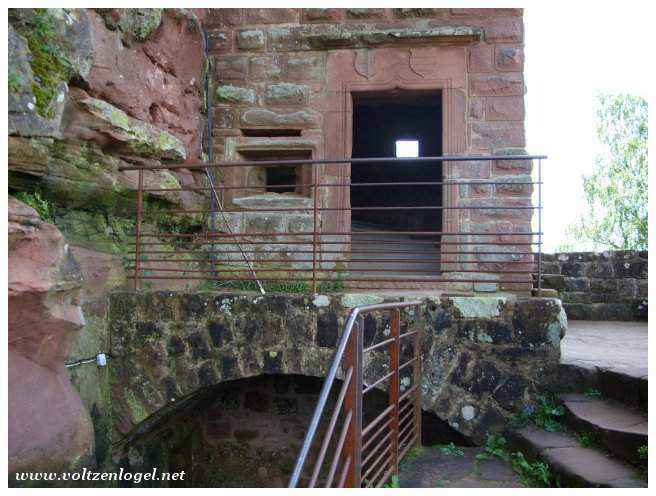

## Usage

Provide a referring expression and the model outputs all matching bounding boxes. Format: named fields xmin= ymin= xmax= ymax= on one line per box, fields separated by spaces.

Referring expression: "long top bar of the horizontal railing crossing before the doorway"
xmin=118 ymin=155 xmax=547 ymax=172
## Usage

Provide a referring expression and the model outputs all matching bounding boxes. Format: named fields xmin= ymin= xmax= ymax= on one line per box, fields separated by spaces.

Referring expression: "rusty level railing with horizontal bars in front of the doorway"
xmin=120 ymin=155 xmax=546 ymax=293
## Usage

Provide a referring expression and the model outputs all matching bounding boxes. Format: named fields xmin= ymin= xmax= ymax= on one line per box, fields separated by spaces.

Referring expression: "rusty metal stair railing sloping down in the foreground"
xmin=289 ymin=301 xmax=421 ymax=487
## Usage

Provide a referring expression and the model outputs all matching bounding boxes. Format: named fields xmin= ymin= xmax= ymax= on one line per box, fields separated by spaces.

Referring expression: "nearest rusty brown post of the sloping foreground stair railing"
xmin=343 ymin=316 xmax=364 ymax=488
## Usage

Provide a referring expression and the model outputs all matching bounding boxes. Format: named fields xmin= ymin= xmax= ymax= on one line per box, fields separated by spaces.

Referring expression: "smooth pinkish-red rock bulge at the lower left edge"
xmin=8 ymin=198 xmax=93 ymax=473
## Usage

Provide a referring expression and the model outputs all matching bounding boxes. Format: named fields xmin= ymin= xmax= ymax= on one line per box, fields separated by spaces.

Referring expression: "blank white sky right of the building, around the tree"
xmin=524 ymin=1 xmax=656 ymax=252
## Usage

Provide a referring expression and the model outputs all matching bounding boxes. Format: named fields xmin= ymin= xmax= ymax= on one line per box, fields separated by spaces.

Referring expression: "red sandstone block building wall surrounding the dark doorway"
xmin=205 ymin=9 xmax=532 ymax=291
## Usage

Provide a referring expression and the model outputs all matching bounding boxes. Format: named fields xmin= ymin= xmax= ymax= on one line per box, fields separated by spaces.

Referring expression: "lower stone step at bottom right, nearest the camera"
xmin=506 ymin=426 xmax=647 ymax=487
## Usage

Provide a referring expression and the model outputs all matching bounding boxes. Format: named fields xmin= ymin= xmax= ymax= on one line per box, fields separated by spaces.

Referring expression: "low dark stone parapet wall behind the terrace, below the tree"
xmin=542 ymin=250 xmax=648 ymax=320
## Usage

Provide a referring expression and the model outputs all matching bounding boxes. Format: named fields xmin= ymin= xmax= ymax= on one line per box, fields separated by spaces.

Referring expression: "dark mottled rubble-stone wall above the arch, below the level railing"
xmin=109 ymin=292 xmax=567 ymax=442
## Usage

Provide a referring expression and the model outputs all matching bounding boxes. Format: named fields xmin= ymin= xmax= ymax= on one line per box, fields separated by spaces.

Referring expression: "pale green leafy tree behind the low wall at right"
xmin=567 ymin=94 xmax=648 ymax=250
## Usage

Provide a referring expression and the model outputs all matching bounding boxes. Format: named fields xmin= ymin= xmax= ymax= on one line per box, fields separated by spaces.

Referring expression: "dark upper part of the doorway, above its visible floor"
xmin=351 ymin=92 xmax=442 ymax=231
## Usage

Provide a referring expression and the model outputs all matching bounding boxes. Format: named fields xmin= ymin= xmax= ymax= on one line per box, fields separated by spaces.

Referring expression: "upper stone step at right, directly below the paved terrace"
xmin=559 ymin=394 xmax=648 ymax=465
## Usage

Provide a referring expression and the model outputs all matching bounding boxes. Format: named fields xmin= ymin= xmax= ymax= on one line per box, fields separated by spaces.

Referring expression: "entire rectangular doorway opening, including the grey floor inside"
xmin=351 ymin=91 xmax=443 ymax=276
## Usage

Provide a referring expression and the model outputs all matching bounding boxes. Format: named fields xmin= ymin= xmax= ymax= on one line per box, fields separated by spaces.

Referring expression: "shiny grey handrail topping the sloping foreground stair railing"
xmin=288 ymin=301 xmax=422 ymax=488
